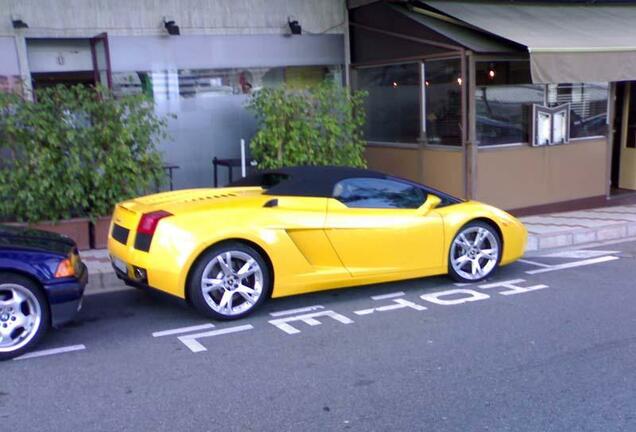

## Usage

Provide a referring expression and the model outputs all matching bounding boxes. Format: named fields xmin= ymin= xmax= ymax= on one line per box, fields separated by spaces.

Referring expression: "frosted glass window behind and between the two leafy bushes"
xmin=113 ymin=65 xmax=342 ymax=188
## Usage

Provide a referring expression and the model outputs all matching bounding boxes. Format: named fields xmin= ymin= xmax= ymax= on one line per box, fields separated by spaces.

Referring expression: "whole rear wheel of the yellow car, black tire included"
xmin=188 ymin=242 xmax=272 ymax=320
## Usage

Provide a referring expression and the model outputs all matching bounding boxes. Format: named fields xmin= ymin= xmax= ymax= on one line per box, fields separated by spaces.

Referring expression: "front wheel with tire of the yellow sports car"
xmin=448 ymin=221 xmax=502 ymax=283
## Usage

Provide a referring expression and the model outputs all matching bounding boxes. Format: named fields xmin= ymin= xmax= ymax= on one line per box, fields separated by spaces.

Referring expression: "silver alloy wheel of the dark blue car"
xmin=0 ymin=283 xmax=42 ymax=353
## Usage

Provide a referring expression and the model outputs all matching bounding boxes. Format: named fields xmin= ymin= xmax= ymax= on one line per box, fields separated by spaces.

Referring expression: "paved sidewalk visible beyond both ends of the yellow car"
xmin=81 ymin=205 xmax=636 ymax=293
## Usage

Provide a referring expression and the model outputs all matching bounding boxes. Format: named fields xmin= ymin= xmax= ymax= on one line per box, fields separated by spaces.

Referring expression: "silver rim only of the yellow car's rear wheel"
xmin=201 ymin=250 xmax=263 ymax=316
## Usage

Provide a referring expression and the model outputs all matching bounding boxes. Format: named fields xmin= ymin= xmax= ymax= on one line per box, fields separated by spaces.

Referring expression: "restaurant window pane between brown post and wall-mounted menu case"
xmin=475 ymin=61 xmax=545 ymax=146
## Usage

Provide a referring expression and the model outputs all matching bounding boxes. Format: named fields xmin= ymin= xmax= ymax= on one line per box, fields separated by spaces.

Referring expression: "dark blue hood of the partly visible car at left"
xmin=0 ymin=224 xmax=75 ymax=255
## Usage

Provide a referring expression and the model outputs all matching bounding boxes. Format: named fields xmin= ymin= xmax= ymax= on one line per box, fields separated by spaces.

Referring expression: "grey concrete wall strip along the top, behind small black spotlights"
xmin=0 ymin=0 xmax=345 ymax=37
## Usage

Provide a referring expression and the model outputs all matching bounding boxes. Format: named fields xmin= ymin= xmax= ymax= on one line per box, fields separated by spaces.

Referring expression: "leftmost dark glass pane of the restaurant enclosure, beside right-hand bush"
xmin=355 ymin=63 xmax=420 ymax=143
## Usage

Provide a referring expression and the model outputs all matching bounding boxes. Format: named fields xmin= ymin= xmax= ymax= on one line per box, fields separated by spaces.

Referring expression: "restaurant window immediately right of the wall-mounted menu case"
xmin=548 ymin=83 xmax=608 ymax=138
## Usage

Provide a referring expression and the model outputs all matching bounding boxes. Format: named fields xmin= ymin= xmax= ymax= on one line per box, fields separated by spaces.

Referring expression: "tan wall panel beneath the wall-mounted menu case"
xmin=477 ymin=138 xmax=609 ymax=209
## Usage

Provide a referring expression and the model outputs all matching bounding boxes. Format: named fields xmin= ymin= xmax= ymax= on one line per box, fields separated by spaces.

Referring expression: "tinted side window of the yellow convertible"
xmin=333 ymin=178 xmax=426 ymax=209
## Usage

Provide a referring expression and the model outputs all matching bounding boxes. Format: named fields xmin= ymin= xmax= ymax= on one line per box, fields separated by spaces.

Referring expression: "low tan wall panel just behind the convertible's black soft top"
xmin=365 ymin=145 xmax=464 ymax=197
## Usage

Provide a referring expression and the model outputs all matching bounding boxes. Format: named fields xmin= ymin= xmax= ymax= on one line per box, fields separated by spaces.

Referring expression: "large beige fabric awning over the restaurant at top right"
xmin=424 ymin=0 xmax=636 ymax=83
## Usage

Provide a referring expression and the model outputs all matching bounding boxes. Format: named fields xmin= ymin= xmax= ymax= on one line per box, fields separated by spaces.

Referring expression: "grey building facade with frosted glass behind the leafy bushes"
xmin=0 ymin=0 xmax=346 ymax=188
